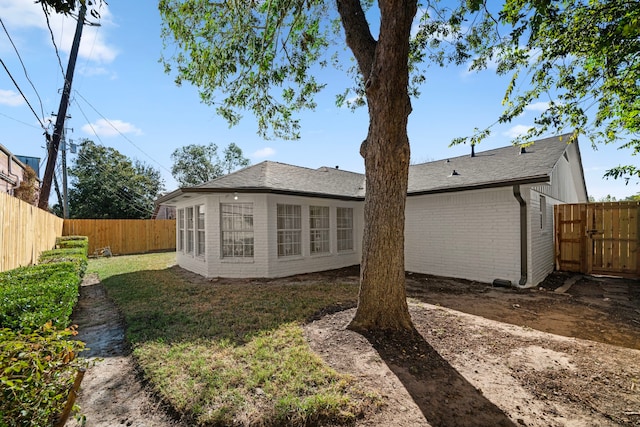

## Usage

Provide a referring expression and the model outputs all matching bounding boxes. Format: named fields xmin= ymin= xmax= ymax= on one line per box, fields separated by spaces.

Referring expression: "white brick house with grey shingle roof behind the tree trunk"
xmin=158 ymin=135 xmax=587 ymax=287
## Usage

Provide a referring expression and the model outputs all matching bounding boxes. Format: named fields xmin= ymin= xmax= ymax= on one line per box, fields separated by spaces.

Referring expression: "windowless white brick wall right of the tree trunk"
xmin=405 ymin=187 xmax=520 ymax=284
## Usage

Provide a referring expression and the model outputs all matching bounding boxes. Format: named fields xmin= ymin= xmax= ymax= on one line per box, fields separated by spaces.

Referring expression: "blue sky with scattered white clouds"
xmin=0 ymin=0 xmax=640 ymax=200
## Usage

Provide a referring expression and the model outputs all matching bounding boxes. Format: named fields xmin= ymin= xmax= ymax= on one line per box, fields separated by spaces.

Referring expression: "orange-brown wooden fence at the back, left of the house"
xmin=62 ymin=219 xmax=176 ymax=255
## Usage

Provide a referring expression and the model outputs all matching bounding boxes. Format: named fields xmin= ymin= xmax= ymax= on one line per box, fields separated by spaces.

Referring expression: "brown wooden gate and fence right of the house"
xmin=554 ymin=201 xmax=640 ymax=278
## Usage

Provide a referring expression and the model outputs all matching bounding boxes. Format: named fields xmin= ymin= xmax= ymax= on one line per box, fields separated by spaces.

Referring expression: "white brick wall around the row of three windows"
xmin=267 ymin=195 xmax=364 ymax=277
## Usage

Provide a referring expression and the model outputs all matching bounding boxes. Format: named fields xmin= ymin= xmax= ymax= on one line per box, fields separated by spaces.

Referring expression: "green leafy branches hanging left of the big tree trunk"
xmin=159 ymin=0 xmax=327 ymax=138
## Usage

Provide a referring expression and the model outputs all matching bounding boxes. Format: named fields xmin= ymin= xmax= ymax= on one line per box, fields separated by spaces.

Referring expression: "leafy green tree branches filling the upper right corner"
xmin=455 ymin=0 xmax=640 ymax=179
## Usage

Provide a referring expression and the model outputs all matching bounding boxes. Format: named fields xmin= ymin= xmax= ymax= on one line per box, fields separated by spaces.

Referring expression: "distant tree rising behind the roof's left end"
xmin=171 ymin=142 xmax=250 ymax=187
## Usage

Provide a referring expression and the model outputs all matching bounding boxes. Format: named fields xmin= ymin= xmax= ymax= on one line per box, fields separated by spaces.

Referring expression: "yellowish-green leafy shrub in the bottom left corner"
xmin=0 ymin=323 xmax=86 ymax=427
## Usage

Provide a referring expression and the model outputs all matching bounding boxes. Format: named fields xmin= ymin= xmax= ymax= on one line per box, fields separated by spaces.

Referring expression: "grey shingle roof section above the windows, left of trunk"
xmin=192 ymin=161 xmax=364 ymax=198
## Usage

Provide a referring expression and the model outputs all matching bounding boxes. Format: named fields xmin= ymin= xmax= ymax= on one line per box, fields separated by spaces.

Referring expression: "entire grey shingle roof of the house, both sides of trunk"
xmin=156 ymin=135 xmax=586 ymax=203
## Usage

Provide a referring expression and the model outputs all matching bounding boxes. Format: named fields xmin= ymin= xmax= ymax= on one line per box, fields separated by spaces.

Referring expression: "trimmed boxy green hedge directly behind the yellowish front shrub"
xmin=0 ymin=262 xmax=80 ymax=331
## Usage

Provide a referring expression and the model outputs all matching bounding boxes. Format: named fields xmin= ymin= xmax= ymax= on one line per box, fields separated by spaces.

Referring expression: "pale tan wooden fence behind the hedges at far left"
xmin=0 ymin=192 xmax=63 ymax=271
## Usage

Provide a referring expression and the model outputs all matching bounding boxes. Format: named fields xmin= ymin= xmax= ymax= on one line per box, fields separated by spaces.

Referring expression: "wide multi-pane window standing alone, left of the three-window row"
xmin=220 ymin=203 xmax=253 ymax=258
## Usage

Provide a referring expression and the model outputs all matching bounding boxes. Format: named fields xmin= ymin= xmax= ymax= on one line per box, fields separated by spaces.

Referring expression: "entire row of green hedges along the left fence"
xmin=0 ymin=237 xmax=87 ymax=427
